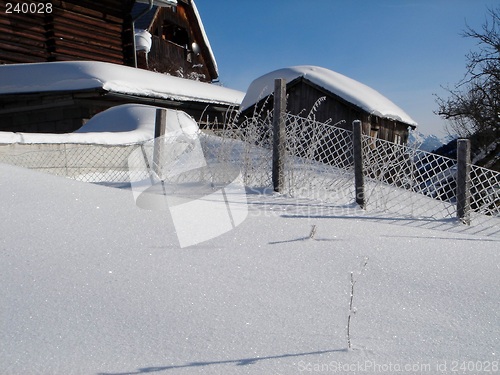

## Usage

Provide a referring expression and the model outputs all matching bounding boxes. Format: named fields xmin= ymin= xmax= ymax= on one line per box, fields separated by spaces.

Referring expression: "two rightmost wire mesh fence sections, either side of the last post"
xmin=363 ymin=136 xmax=500 ymax=234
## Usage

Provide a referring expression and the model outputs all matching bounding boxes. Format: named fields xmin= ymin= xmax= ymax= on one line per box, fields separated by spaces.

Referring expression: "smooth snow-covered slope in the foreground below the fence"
xmin=0 ymin=165 xmax=500 ymax=375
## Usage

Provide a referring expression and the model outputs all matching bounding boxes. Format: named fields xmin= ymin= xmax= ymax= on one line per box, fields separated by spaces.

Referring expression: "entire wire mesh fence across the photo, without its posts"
xmin=0 ymin=113 xmax=500 ymax=235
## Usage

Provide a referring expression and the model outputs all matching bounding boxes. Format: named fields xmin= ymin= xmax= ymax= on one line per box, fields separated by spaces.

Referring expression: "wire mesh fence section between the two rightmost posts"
xmin=362 ymin=136 xmax=457 ymax=219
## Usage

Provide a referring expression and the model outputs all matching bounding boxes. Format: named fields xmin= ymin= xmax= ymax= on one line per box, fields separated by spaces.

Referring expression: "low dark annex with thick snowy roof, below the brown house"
xmin=0 ymin=61 xmax=244 ymax=133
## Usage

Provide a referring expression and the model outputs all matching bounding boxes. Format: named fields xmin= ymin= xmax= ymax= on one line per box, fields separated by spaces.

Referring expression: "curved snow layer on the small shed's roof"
xmin=241 ymin=66 xmax=417 ymax=126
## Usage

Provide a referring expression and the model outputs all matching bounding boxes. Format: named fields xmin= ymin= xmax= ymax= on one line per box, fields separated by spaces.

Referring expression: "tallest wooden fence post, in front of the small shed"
xmin=273 ymin=78 xmax=286 ymax=192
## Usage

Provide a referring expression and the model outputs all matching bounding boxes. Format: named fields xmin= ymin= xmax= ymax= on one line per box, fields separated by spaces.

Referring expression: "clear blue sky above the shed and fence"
xmin=196 ymin=0 xmax=500 ymax=135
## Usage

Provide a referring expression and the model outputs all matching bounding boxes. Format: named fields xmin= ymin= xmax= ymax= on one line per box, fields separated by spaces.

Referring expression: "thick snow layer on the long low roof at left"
xmin=0 ymin=61 xmax=244 ymax=105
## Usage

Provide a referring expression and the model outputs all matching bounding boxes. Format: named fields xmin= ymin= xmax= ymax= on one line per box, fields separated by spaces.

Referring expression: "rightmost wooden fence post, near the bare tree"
xmin=457 ymin=139 xmax=470 ymax=225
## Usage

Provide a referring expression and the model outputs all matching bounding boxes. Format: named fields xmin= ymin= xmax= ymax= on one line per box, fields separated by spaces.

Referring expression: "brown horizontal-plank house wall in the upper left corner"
xmin=0 ymin=0 xmax=133 ymax=64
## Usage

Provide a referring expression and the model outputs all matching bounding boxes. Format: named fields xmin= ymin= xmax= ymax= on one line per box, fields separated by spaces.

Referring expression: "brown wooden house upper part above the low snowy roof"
xmin=0 ymin=0 xmax=218 ymax=82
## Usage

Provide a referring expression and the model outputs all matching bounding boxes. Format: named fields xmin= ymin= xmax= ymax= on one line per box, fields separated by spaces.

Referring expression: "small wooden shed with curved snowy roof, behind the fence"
xmin=241 ymin=66 xmax=417 ymax=143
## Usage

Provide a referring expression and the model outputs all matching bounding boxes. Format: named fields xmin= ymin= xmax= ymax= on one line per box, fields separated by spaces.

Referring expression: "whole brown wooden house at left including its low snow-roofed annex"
xmin=0 ymin=0 xmax=236 ymax=133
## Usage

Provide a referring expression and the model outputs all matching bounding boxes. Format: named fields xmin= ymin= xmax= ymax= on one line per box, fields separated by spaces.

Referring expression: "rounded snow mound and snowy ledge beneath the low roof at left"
xmin=0 ymin=104 xmax=199 ymax=145
